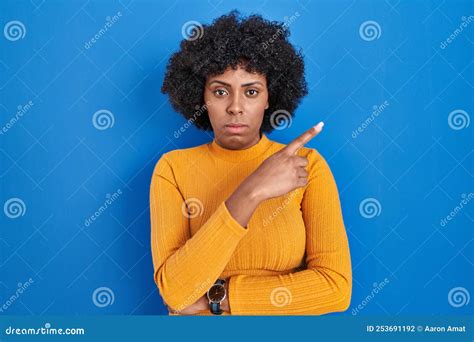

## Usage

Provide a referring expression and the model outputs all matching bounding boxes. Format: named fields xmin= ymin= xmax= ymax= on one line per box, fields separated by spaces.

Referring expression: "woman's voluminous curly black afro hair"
xmin=161 ymin=10 xmax=308 ymax=132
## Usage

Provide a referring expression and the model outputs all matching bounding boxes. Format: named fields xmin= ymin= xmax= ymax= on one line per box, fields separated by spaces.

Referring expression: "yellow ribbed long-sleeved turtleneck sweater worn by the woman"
xmin=150 ymin=134 xmax=352 ymax=315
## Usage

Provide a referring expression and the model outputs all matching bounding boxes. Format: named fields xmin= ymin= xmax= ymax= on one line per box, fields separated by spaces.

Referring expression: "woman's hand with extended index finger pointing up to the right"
xmin=242 ymin=122 xmax=324 ymax=201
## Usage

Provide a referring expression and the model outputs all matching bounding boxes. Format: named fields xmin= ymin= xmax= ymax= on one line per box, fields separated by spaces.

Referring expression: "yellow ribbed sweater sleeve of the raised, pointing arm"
xmin=150 ymin=154 xmax=247 ymax=310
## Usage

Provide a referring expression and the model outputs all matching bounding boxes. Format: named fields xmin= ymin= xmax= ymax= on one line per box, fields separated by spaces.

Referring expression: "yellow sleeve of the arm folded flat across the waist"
xmin=229 ymin=149 xmax=352 ymax=315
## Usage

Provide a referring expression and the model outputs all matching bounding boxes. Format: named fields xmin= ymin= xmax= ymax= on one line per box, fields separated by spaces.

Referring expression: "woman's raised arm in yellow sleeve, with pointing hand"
xmin=154 ymin=123 xmax=323 ymax=311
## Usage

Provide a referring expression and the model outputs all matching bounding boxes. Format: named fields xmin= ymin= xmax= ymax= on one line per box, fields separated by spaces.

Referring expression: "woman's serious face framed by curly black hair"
xmin=204 ymin=67 xmax=269 ymax=150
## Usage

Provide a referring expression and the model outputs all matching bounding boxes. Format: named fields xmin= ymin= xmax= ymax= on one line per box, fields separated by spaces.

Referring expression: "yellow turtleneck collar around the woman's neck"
xmin=208 ymin=133 xmax=272 ymax=162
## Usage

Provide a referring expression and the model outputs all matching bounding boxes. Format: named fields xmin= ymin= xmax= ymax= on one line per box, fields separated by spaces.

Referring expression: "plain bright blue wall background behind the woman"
xmin=0 ymin=0 xmax=474 ymax=315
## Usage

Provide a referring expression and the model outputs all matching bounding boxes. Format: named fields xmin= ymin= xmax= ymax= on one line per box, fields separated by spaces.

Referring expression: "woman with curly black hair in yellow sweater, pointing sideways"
xmin=150 ymin=12 xmax=352 ymax=315
